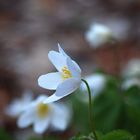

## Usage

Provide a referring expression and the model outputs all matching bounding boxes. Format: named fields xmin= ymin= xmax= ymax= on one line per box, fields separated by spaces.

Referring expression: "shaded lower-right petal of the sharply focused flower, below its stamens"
xmin=54 ymin=78 xmax=81 ymax=97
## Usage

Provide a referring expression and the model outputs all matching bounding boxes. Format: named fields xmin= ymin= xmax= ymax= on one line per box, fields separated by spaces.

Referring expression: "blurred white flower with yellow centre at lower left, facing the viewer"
xmin=17 ymin=96 xmax=70 ymax=134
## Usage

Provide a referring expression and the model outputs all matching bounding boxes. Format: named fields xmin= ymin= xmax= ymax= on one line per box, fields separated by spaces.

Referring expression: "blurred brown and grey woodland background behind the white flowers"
xmin=0 ymin=0 xmax=140 ymax=140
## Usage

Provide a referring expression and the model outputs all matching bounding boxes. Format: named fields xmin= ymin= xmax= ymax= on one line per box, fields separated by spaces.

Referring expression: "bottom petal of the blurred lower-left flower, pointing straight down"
xmin=34 ymin=117 xmax=50 ymax=134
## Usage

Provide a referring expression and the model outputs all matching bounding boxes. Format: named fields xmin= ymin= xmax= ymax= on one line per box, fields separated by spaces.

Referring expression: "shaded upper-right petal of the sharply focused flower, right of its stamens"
xmin=67 ymin=57 xmax=81 ymax=78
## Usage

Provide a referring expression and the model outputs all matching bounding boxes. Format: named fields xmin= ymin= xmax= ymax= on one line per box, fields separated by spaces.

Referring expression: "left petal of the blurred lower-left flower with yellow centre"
xmin=17 ymin=109 xmax=35 ymax=128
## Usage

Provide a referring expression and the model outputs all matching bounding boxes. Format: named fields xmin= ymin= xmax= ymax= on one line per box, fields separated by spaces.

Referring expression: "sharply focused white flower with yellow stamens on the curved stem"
xmin=38 ymin=44 xmax=81 ymax=103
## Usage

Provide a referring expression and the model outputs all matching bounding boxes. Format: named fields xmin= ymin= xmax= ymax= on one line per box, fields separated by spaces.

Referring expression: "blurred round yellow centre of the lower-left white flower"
xmin=37 ymin=103 xmax=49 ymax=118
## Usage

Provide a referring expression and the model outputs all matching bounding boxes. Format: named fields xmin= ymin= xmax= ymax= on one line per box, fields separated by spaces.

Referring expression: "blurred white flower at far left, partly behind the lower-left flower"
xmin=5 ymin=91 xmax=33 ymax=117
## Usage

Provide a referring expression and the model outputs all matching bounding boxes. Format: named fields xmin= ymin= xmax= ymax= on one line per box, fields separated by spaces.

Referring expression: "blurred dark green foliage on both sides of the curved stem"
xmin=70 ymin=76 xmax=140 ymax=140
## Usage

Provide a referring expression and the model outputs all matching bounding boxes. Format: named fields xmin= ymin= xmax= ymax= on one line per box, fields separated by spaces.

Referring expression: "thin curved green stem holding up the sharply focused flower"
xmin=81 ymin=79 xmax=98 ymax=140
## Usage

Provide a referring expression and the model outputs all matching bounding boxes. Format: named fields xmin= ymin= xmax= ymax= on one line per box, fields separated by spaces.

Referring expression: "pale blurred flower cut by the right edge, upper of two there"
xmin=122 ymin=59 xmax=140 ymax=78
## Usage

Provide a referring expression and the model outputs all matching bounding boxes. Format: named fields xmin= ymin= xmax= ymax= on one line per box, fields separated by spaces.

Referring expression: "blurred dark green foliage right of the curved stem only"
xmin=94 ymin=79 xmax=140 ymax=140
